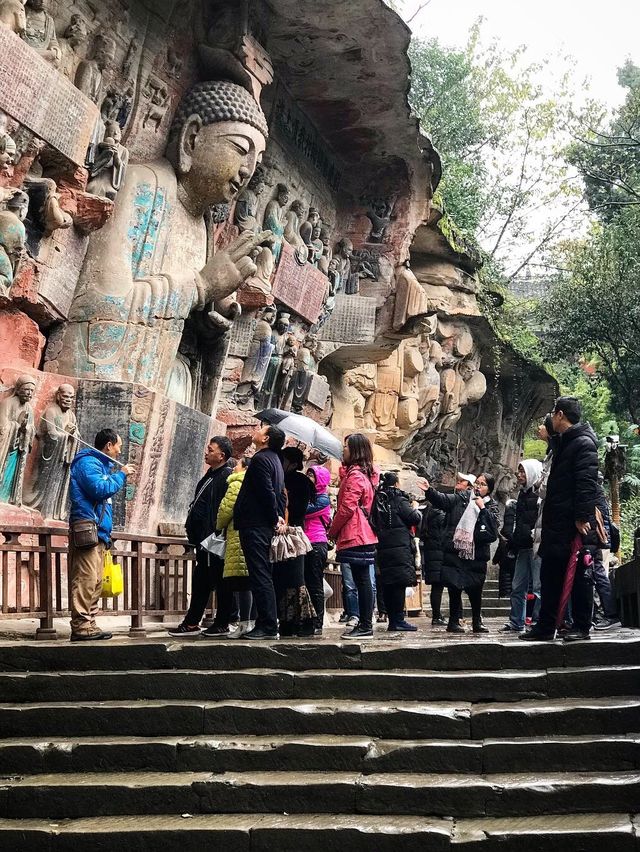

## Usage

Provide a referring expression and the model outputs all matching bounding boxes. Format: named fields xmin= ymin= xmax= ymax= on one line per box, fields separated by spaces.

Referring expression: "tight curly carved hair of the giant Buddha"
xmin=169 ymin=80 xmax=269 ymax=138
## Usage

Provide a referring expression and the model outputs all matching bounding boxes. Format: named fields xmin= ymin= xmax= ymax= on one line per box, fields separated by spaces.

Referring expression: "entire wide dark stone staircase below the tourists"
xmin=0 ymin=631 xmax=640 ymax=852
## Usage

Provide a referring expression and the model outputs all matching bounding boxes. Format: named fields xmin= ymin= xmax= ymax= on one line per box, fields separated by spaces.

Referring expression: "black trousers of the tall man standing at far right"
xmin=537 ymin=549 xmax=593 ymax=633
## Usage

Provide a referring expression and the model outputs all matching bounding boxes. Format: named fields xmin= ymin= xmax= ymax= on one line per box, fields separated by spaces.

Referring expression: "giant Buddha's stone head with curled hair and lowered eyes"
xmin=167 ymin=81 xmax=268 ymax=211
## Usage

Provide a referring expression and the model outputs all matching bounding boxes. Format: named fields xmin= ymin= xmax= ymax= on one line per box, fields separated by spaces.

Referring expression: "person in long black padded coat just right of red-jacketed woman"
xmin=371 ymin=471 xmax=422 ymax=633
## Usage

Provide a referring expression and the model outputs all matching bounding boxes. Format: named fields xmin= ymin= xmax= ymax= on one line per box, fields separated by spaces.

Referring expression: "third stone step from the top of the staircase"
xmin=0 ymin=697 xmax=640 ymax=740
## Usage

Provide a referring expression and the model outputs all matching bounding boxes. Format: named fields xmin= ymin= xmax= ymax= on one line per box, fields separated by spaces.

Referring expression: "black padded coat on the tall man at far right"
xmin=540 ymin=423 xmax=598 ymax=562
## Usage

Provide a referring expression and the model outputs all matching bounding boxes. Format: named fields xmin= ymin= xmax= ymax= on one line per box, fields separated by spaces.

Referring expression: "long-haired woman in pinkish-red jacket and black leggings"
xmin=328 ymin=433 xmax=379 ymax=639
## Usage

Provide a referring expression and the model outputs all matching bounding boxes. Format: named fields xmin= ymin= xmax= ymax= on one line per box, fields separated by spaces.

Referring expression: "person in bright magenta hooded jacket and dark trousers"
xmin=304 ymin=466 xmax=331 ymax=636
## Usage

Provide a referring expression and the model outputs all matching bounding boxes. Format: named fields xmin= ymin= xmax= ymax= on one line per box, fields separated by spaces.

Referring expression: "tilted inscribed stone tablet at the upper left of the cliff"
xmin=0 ymin=26 xmax=99 ymax=166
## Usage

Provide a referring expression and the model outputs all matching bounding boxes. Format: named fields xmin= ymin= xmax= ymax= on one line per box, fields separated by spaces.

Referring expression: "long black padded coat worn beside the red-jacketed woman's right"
xmin=371 ymin=488 xmax=422 ymax=586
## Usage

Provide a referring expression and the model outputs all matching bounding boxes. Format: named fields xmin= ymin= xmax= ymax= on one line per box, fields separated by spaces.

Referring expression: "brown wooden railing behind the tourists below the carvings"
xmin=0 ymin=525 xmax=342 ymax=639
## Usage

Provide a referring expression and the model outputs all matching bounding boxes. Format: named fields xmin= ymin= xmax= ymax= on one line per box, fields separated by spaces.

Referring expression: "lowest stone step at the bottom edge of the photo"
xmin=0 ymin=813 xmax=638 ymax=852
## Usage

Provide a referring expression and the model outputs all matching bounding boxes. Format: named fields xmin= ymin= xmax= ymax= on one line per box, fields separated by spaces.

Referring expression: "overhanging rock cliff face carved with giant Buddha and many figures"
xmin=0 ymin=0 xmax=551 ymax=532
